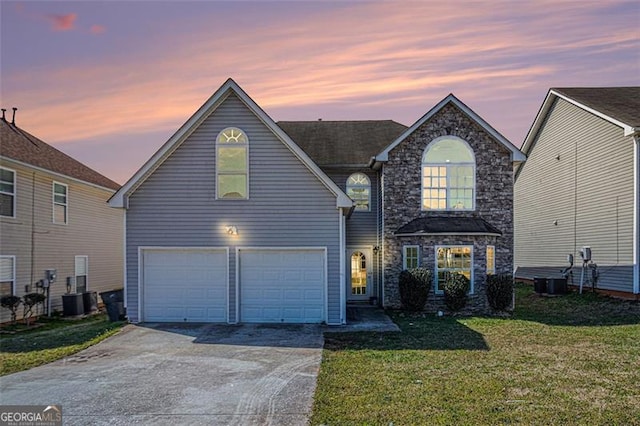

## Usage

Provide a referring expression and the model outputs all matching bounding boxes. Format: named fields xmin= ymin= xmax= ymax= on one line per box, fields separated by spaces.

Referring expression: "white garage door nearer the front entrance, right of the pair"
xmin=240 ymin=249 xmax=325 ymax=323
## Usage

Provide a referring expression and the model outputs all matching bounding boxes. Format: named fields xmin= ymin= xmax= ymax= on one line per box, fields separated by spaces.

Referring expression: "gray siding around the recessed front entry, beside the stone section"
xmin=323 ymin=168 xmax=381 ymax=297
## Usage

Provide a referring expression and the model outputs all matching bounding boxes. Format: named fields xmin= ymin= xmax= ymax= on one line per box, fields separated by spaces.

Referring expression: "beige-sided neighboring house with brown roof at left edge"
xmin=0 ymin=118 xmax=124 ymax=321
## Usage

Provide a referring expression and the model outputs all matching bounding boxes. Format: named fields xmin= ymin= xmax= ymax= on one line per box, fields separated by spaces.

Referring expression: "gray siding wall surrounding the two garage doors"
xmin=127 ymin=95 xmax=342 ymax=323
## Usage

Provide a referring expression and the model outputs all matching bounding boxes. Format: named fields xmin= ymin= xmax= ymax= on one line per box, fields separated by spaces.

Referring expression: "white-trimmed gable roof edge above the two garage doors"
xmin=109 ymin=78 xmax=353 ymax=208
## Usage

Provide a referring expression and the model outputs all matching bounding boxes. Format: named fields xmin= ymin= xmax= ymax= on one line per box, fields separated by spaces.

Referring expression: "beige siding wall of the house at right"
xmin=515 ymin=99 xmax=634 ymax=292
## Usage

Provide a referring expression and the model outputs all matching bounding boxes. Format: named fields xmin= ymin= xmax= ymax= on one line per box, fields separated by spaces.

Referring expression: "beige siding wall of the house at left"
xmin=0 ymin=159 xmax=124 ymax=321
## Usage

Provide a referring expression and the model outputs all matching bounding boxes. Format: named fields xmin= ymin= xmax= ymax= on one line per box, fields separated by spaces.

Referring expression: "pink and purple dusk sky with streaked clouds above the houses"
xmin=0 ymin=0 xmax=640 ymax=183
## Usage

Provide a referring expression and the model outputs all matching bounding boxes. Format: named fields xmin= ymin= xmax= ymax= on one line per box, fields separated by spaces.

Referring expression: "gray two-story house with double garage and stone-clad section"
xmin=110 ymin=79 xmax=524 ymax=325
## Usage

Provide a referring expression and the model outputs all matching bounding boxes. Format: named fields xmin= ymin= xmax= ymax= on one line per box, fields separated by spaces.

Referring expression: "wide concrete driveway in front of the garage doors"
xmin=0 ymin=324 xmax=322 ymax=425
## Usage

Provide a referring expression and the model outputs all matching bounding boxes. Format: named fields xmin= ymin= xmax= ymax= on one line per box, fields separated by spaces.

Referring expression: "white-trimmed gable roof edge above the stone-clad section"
xmin=375 ymin=93 xmax=527 ymax=162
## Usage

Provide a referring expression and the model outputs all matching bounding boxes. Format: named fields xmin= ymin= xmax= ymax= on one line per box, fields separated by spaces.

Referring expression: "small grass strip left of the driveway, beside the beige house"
xmin=0 ymin=315 xmax=123 ymax=376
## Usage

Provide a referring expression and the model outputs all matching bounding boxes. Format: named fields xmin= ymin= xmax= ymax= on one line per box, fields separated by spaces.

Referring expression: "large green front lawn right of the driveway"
xmin=311 ymin=285 xmax=640 ymax=426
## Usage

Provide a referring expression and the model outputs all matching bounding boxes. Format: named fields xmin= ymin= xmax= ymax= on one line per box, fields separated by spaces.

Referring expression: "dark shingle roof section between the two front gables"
xmin=278 ymin=120 xmax=407 ymax=167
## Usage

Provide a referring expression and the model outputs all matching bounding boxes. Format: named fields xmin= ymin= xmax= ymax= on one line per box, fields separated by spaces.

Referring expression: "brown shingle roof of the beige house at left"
xmin=0 ymin=119 xmax=120 ymax=191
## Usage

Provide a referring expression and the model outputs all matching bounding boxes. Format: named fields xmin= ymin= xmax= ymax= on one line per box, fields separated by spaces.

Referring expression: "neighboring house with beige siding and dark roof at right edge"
xmin=515 ymin=87 xmax=640 ymax=297
